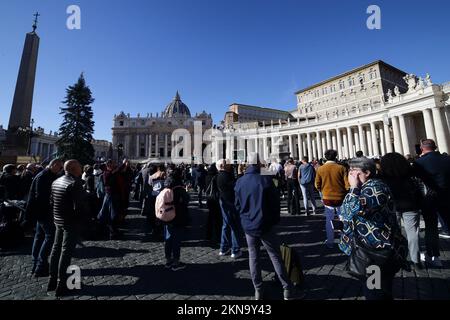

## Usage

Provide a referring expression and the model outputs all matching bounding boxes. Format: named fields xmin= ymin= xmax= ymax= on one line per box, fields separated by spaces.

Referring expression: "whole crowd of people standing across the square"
xmin=0 ymin=139 xmax=450 ymax=300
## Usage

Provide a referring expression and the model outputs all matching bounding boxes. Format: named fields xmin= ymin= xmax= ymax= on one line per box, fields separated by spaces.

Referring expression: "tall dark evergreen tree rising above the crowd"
xmin=56 ymin=74 xmax=95 ymax=165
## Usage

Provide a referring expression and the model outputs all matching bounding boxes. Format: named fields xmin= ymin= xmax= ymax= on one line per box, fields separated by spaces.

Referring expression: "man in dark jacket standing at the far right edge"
xmin=413 ymin=139 xmax=450 ymax=267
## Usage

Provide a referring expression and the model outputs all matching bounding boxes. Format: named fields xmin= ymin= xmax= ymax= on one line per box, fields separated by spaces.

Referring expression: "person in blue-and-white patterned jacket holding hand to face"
xmin=340 ymin=157 xmax=404 ymax=300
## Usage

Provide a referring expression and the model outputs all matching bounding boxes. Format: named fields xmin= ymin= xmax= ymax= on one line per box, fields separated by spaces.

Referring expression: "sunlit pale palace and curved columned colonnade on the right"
xmin=213 ymin=61 xmax=450 ymax=161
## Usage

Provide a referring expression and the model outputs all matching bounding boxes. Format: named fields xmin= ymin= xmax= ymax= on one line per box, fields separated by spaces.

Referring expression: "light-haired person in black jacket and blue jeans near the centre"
xmin=216 ymin=159 xmax=242 ymax=259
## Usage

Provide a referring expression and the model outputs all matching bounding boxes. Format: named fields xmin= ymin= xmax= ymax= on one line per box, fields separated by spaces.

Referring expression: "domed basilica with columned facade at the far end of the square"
xmin=112 ymin=92 xmax=212 ymax=162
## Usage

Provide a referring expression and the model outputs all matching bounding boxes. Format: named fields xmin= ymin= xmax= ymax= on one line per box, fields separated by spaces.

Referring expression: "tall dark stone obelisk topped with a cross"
xmin=6 ymin=13 xmax=40 ymax=156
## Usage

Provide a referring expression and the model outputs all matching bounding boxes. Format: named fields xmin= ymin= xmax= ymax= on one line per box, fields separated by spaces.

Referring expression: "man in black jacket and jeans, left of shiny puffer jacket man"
xmin=26 ymin=159 xmax=63 ymax=277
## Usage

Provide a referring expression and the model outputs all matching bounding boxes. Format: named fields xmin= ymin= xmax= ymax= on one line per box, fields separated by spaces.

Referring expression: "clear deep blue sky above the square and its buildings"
xmin=0 ymin=0 xmax=450 ymax=140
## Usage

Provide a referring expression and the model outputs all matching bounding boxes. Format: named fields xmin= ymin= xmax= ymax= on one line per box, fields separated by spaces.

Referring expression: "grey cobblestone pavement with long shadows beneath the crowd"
xmin=0 ymin=192 xmax=450 ymax=300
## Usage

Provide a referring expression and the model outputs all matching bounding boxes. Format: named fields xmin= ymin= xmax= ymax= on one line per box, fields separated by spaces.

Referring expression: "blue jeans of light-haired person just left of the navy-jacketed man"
xmin=220 ymin=200 xmax=241 ymax=253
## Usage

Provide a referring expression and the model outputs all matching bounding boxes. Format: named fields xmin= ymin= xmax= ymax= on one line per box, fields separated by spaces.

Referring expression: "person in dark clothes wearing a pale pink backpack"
xmin=155 ymin=168 xmax=189 ymax=271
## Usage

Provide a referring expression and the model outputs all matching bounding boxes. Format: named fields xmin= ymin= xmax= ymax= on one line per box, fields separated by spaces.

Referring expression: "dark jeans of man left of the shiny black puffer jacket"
xmin=31 ymin=219 xmax=55 ymax=270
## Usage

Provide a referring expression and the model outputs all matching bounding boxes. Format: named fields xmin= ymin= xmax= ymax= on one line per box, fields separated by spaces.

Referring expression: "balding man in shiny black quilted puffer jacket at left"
xmin=47 ymin=160 xmax=89 ymax=296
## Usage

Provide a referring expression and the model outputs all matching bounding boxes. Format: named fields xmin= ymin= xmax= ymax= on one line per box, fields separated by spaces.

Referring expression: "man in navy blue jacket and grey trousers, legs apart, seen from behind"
xmin=234 ymin=153 xmax=304 ymax=300
